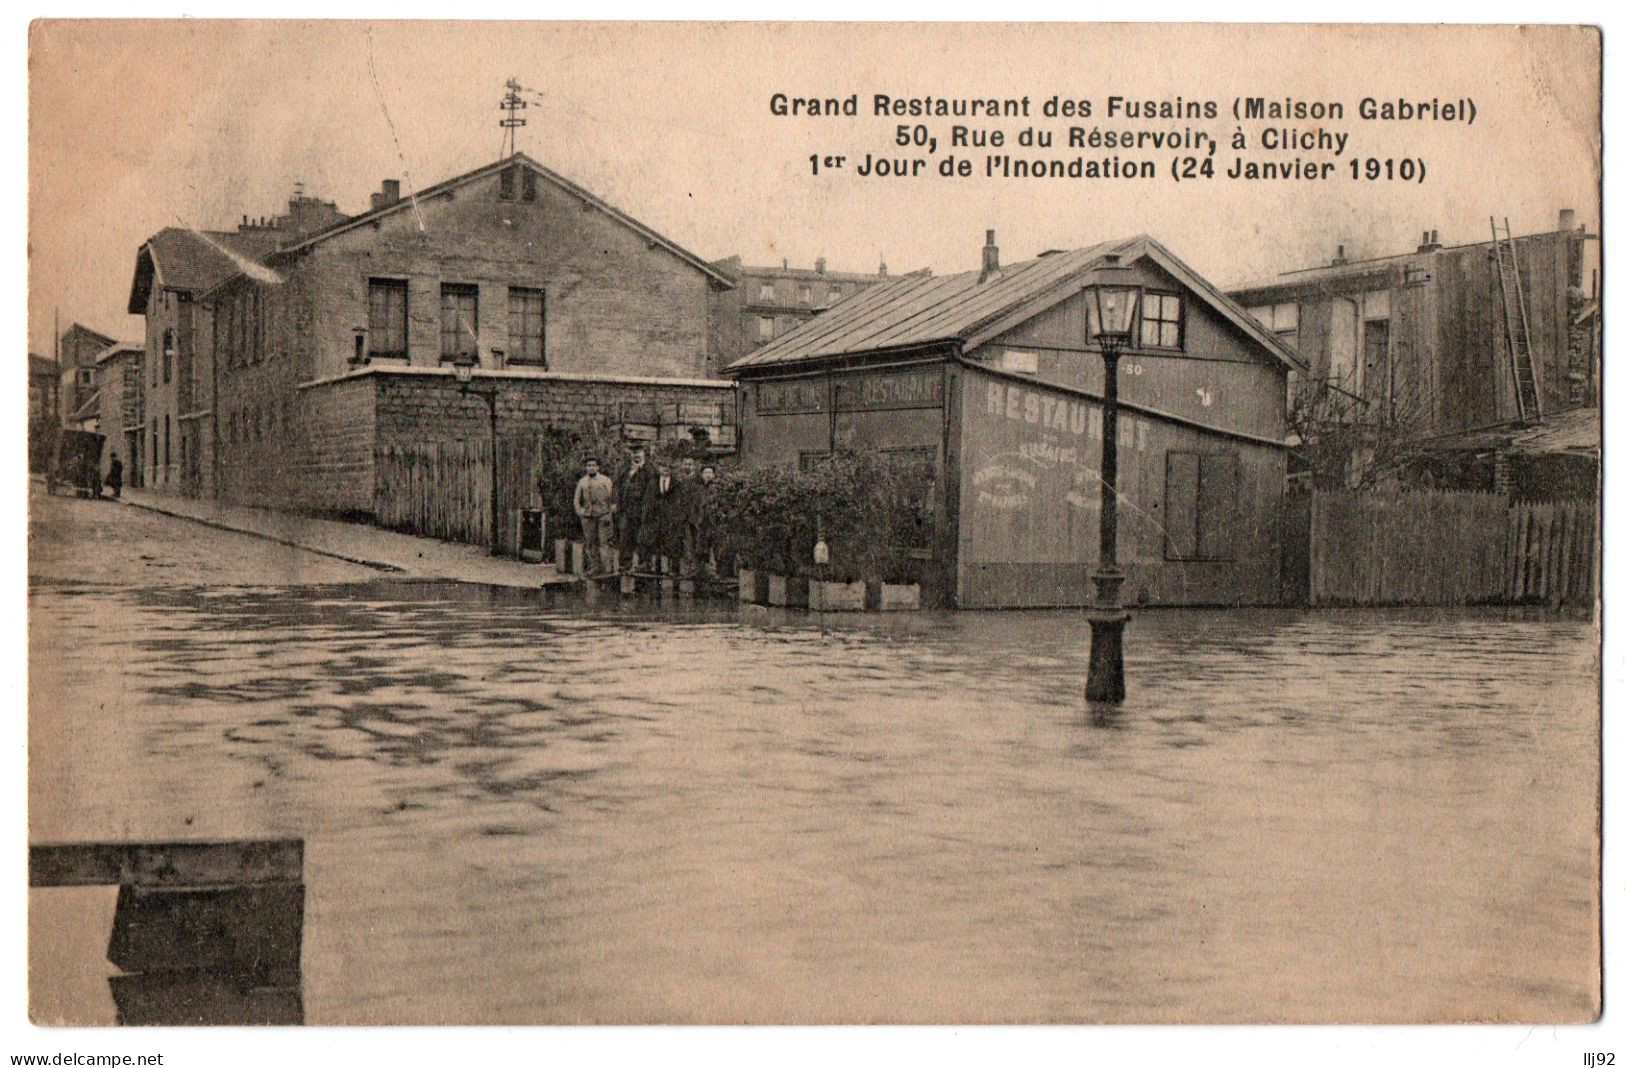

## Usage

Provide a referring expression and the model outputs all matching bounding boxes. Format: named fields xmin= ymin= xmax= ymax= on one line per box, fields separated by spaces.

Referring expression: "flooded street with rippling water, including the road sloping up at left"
xmin=29 ymin=497 xmax=1599 ymax=1024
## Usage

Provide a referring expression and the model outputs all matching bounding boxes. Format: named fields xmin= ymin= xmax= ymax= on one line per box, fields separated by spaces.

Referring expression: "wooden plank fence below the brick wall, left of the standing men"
xmin=377 ymin=439 xmax=540 ymax=554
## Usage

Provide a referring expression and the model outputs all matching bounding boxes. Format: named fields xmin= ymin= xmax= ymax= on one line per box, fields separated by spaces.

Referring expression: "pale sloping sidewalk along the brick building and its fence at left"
xmin=122 ymin=489 xmax=577 ymax=588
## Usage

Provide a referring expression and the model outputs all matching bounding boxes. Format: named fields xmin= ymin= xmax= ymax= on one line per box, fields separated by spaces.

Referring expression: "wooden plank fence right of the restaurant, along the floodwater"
xmin=1310 ymin=491 xmax=1597 ymax=611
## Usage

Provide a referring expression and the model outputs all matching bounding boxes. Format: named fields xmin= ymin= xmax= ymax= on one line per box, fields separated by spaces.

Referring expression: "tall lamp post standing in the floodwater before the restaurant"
xmin=1084 ymin=279 xmax=1139 ymax=704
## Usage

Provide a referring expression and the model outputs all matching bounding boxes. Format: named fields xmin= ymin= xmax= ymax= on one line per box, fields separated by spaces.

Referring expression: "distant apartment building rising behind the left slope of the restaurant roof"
xmin=712 ymin=255 xmax=930 ymax=369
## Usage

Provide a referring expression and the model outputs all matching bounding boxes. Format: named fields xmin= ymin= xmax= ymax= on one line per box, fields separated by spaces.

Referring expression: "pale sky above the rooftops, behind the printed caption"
xmin=29 ymin=20 xmax=1599 ymax=354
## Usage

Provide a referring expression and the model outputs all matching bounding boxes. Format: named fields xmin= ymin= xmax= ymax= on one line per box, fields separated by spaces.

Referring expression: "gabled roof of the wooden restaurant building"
xmin=725 ymin=234 xmax=1303 ymax=372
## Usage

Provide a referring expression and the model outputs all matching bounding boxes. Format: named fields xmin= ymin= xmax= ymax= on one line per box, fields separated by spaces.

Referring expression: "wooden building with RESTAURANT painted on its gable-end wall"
xmin=726 ymin=231 xmax=1302 ymax=608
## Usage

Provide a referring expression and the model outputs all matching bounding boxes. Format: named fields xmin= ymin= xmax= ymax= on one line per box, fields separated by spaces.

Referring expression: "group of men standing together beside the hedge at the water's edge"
xmin=575 ymin=445 xmax=717 ymax=577
